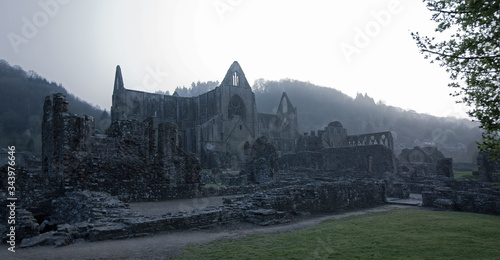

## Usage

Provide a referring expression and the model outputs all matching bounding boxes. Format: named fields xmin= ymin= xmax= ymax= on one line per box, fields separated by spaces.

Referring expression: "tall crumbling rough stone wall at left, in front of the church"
xmin=42 ymin=94 xmax=201 ymax=201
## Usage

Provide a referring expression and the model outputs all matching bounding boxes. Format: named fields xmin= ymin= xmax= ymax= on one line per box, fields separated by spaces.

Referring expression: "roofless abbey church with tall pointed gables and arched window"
xmin=111 ymin=61 xmax=299 ymax=169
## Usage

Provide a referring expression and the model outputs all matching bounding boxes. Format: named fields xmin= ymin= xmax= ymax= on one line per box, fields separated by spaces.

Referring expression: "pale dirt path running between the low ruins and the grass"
xmin=0 ymin=205 xmax=420 ymax=260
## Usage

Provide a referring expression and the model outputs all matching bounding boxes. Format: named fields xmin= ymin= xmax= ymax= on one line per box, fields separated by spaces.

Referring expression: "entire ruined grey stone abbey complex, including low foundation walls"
xmin=0 ymin=62 xmax=500 ymax=250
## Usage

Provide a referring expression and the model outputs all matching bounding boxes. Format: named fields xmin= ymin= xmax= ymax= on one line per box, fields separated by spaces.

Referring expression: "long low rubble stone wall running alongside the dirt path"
xmin=16 ymin=180 xmax=385 ymax=247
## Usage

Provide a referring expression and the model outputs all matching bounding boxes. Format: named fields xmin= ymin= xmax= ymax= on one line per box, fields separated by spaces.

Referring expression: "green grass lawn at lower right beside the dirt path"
xmin=175 ymin=210 xmax=500 ymax=259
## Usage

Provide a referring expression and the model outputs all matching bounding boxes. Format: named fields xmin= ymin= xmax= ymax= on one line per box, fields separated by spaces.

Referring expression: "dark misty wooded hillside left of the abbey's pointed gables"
xmin=0 ymin=60 xmax=109 ymax=153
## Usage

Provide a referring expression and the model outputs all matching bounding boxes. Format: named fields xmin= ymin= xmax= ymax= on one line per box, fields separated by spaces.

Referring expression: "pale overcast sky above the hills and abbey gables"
xmin=0 ymin=0 xmax=467 ymax=117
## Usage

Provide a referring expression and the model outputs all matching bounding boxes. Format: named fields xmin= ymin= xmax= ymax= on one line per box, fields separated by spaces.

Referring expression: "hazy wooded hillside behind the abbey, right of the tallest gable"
xmin=176 ymin=79 xmax=481 ymax=162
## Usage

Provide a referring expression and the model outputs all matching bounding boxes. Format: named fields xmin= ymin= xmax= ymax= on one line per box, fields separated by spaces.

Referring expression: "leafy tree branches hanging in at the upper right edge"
xmin=412 ymin=0 xmax=500 ymax=159
